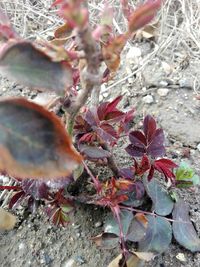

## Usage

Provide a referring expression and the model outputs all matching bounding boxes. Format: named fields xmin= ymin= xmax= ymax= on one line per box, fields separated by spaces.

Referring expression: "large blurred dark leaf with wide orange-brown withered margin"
xmin=0 ymin=98 xmax=82 ymax=179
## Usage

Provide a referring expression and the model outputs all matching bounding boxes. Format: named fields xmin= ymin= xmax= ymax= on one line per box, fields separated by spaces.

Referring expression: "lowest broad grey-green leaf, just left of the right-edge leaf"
xmin=139 ymin=215 xmax=172 ymax=253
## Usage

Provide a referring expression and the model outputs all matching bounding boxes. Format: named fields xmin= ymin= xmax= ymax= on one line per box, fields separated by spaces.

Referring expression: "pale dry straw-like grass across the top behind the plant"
xmin=0 ymin=0 xmax=200 ymax=91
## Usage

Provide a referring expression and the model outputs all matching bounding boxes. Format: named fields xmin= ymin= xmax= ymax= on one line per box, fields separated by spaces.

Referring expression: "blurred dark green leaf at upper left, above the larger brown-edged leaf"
xmin=0 ymin=41 xmax=73 ymax=94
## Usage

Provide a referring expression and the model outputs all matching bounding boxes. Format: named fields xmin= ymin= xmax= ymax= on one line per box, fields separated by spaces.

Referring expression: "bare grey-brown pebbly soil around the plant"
xmin=0 ymin=1 xmax=200 ymax=267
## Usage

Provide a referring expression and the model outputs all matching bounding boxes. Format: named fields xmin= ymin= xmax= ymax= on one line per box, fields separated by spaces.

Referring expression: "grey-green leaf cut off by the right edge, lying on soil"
xmin=172 ymin=199 xmax=200 ymax=252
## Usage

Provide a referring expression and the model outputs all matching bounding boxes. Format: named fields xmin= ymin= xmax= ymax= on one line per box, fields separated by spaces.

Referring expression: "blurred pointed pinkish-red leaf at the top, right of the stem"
xmin=129 ymin=0 xmax=162 ymax=34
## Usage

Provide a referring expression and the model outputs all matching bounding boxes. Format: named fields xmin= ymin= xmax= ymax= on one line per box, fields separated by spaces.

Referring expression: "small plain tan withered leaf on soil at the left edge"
xmin=0 ymin=208 xmax=16 ymax=230
